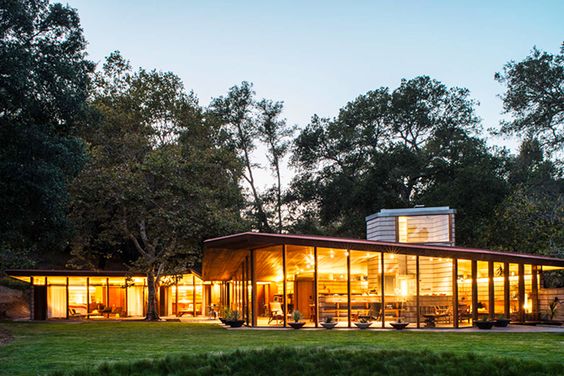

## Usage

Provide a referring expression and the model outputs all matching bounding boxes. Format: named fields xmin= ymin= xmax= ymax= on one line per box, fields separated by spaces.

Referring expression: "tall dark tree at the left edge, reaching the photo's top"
xmin=0 ymin=0 xmax=93 ymax=268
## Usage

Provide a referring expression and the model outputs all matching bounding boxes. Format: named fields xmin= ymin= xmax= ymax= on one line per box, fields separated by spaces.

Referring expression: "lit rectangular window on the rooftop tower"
xmin=397 ymin=215 xmax=450 ymax=243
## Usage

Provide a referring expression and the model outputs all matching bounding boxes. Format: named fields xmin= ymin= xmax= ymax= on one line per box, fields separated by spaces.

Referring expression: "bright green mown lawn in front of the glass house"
xmin=0 ymin=322 xmax=564 ymax=375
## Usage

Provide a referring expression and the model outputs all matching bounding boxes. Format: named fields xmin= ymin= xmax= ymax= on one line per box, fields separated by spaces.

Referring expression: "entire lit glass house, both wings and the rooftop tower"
xmin=8 ymin=207 xmax=564 ymax=328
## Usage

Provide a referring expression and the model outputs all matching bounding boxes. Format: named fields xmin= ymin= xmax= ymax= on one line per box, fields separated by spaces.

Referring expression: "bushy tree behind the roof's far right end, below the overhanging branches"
xmin=486 ymin=140 xmax=564 ymax=257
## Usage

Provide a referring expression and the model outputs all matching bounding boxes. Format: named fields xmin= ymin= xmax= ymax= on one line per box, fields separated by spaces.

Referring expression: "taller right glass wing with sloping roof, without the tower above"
xmin=202 ymin=232 xmax=564 ymax=328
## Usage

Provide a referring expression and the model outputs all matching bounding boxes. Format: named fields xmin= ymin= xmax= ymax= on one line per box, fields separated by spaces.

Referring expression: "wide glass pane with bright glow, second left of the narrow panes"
xmin=383 ymin=253 xmax=417 ymax=327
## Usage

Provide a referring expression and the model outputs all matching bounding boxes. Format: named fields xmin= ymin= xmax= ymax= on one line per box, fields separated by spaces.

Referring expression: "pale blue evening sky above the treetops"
xmin=68 ymin=0 xmax=564 ymax=187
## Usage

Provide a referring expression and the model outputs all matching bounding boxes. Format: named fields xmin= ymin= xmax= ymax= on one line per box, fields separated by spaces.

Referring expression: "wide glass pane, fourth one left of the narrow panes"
xmin=317 ymin=248 xmax=349 ymax=327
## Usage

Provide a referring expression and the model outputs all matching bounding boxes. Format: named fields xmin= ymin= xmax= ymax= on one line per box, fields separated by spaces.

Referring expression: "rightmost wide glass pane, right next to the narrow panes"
xmin=419 ymin=256 xmax=454 ymax=327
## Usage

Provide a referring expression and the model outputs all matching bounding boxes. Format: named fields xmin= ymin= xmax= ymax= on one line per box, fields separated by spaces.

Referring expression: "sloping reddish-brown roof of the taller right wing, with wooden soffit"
xmin=202 ymin=232 xmax=564 ymax=280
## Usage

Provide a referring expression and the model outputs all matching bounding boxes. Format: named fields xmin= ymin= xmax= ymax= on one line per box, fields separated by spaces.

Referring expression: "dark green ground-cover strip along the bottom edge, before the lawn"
xmin=50 ymin=347 xmax=560 ymax=376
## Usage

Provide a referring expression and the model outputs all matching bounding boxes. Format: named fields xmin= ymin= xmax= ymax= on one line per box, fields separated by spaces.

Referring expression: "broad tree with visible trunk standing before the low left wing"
xmin=68 ymin=54 xmax=242 ymax=320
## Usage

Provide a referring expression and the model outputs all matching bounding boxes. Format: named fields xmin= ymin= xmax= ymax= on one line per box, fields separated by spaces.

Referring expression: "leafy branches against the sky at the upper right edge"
xmin=495 ymin=44 xmax=564 ymax=151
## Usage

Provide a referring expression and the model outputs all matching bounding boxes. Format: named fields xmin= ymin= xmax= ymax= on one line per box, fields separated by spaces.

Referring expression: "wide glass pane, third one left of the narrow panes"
xmin=350 ymin=251 xmax=382 ymax=327
